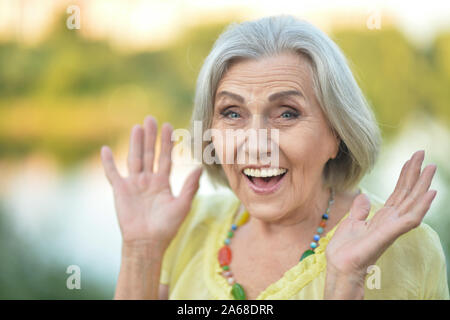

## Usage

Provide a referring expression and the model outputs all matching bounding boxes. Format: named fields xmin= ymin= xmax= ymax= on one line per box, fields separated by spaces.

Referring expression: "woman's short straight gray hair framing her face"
xmin=191 ymin=15 xmax=381 ymax=191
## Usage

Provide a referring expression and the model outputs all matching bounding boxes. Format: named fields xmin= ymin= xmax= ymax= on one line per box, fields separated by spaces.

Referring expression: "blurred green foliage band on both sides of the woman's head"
xmin=0 ymin=19 xmax=450 ymax=165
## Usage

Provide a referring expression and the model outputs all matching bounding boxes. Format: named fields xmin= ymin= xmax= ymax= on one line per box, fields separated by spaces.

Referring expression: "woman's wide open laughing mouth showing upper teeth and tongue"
xmin=242 ymin=168 xmax=288 ymax=193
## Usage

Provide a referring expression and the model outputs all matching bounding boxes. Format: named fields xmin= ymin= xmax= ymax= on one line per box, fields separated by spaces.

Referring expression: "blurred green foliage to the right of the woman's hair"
xmin=333 ymin=28 xmax=450 ymax=137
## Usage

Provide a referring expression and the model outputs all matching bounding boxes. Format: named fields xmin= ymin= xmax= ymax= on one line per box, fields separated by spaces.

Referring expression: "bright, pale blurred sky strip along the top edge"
xmin=0 ymin=0 xmax=450 ymax=50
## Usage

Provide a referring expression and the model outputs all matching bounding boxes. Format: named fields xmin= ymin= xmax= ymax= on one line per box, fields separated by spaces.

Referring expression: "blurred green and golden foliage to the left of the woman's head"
xmin=0 ymin=20 xmax=232 ymax=165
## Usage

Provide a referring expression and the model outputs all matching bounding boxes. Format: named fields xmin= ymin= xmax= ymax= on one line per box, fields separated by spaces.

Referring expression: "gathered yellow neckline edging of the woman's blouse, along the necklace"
xmin=203 ymin=191 xmax=354 ymax=300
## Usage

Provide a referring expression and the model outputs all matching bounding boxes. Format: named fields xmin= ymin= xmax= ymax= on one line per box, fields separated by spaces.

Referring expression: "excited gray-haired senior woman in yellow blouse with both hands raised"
xmin=101 ymin=16 xmax=449 ymax=299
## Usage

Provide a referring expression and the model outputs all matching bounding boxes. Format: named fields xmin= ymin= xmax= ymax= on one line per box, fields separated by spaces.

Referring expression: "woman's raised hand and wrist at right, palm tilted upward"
xmin=324 ymin=151 xmax=436 ymax=299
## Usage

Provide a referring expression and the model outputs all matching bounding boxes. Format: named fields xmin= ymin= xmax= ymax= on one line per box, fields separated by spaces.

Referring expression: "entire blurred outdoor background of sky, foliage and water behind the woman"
xmin=0 ymin=0 xmax=450 ymax=299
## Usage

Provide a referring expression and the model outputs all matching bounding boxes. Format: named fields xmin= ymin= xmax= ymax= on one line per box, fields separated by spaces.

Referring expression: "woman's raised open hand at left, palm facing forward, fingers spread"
xmin=101 ymin=116 xmax=202 ymax=251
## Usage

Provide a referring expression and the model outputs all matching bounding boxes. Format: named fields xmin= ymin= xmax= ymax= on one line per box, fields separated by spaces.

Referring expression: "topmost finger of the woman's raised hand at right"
xmin=388 ymin=150 xmax=425 ymax=206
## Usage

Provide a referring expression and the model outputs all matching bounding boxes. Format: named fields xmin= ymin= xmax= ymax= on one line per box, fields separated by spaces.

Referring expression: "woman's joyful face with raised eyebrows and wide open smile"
xmin=212 ymin=53 xmax=339 ymax=221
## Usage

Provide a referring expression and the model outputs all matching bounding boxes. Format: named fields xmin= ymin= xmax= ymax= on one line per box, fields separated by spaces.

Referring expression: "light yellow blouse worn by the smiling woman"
xmin=160 ymin=188 xmax=449 ymax=300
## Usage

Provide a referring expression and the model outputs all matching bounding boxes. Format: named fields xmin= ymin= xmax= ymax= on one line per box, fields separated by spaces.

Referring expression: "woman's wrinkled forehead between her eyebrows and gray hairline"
xmin=217 ymin=52 xmax=312 ymax=94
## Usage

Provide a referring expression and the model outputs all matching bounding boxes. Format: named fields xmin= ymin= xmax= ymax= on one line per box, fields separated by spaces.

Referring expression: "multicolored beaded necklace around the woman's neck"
xmin=218 ymin=189 xmax=334 ymax=300
